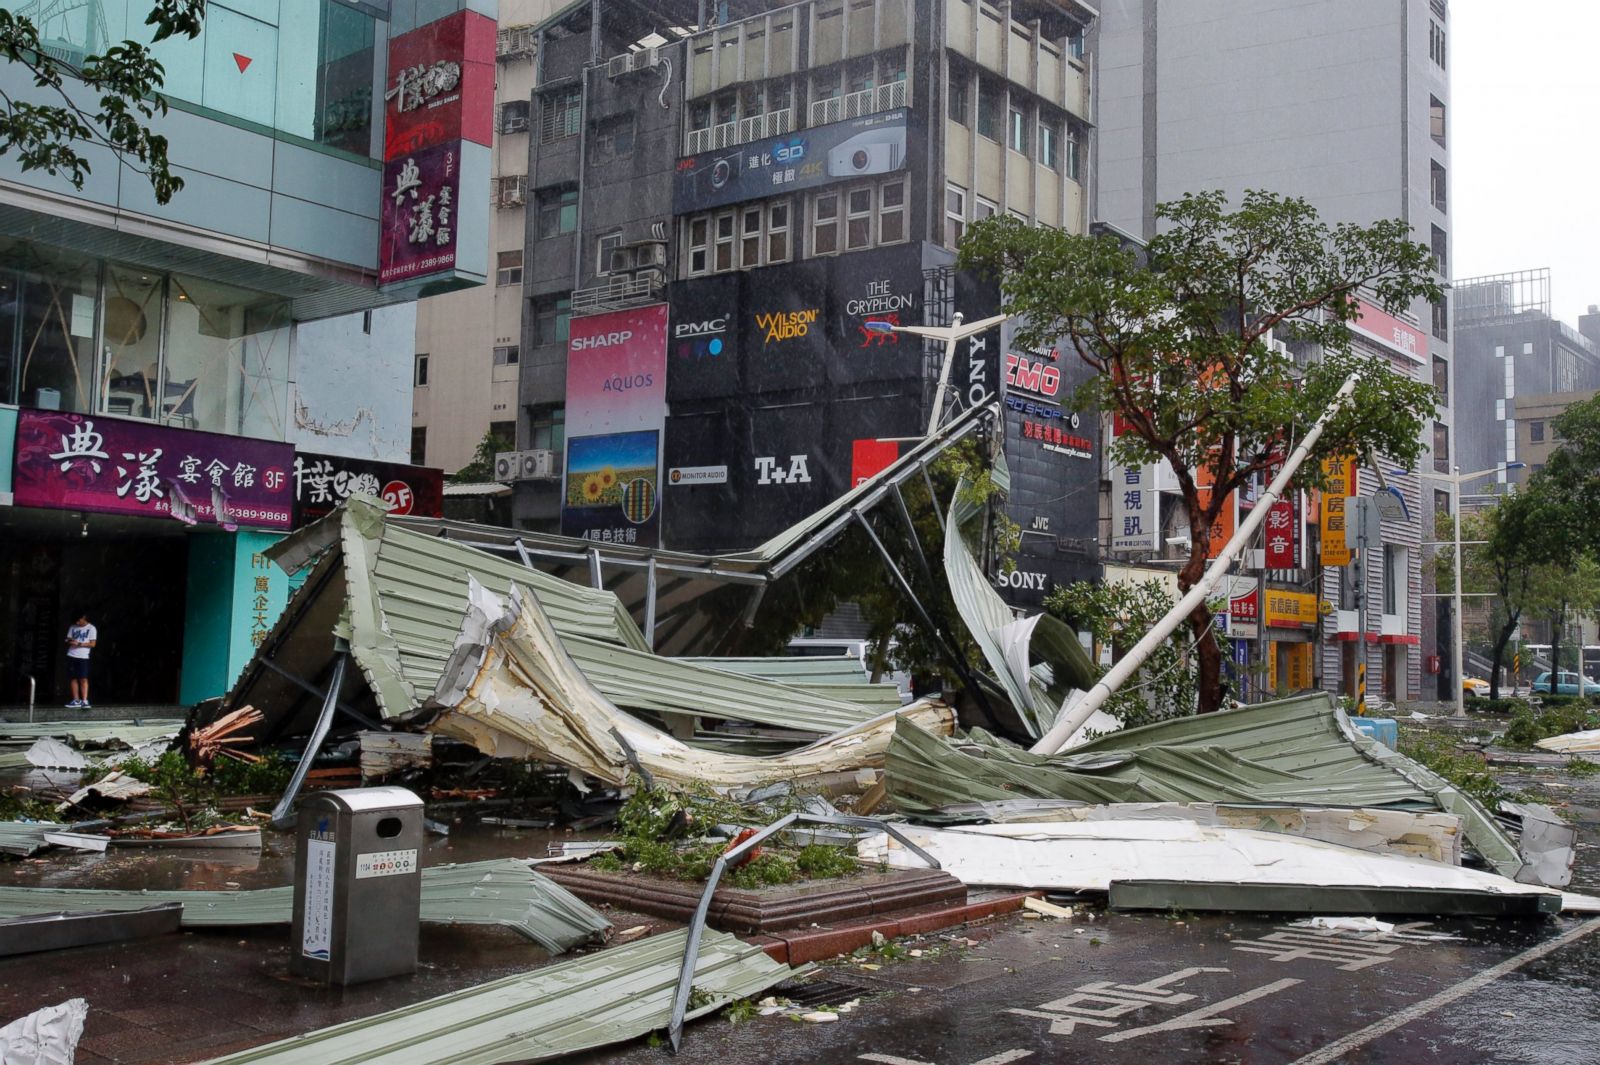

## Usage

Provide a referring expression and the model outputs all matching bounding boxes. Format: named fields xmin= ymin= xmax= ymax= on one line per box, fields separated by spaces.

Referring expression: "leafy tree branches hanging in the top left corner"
xmin=0 ymin=0 xmax=205 ymax=203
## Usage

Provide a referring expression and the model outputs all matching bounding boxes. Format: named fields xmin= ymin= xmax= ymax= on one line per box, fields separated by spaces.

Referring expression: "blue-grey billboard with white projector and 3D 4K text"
xmin=672 ymin=107 xmax=907 ymax=214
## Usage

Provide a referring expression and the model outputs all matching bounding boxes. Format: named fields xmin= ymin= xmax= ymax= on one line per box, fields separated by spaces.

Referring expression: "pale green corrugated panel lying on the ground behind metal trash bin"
xmin=0 ymin=859 xmax=611 ymax=953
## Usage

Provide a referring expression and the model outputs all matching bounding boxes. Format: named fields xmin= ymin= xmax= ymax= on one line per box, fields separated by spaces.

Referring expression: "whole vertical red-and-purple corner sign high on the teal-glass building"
xmin=378 ymin=11 xmax=496 ymax=285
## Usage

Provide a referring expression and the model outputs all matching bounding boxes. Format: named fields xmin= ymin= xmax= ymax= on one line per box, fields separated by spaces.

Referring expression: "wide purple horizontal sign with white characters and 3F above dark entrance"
xmin=13 ymin=409 xmax=294 ymax=529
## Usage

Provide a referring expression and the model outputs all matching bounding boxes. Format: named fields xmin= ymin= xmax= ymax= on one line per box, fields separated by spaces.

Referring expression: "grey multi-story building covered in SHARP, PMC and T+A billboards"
xmin=515 ymin=0 xmax=1099 ymax=601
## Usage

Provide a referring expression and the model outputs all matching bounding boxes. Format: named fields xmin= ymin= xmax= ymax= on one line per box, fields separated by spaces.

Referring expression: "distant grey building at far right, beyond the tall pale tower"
xmin=1454 ymin=270 xmax=1600 ymax=485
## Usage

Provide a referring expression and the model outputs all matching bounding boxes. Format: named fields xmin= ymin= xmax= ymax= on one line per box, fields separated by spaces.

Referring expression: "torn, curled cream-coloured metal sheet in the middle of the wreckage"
xmin=429 ymin=580 xmax=954 ymax=787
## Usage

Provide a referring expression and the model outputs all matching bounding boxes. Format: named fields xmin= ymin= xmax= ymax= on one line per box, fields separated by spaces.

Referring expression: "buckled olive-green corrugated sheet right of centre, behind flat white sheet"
xmin=885 ymin=692 xmax=1523 ymax=876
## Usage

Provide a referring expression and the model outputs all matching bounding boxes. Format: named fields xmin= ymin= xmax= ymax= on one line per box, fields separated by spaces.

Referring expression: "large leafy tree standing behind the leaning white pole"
xmin=960 ymin=192 xmax=1442 ymax=712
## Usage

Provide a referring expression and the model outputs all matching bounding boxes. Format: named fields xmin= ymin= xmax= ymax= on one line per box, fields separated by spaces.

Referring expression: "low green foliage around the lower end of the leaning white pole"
xmin=1045 ymin=580 xmax=1219 ymax=728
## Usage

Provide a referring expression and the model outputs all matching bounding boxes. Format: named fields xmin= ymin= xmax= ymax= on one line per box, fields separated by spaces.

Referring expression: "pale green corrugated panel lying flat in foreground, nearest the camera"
xmin=210 ymin=931 xmax=790 ymax=1065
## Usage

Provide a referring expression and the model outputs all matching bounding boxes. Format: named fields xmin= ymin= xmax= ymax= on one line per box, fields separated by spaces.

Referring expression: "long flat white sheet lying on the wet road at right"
xmin=858 ymin=820 xmax=1600 ymax=913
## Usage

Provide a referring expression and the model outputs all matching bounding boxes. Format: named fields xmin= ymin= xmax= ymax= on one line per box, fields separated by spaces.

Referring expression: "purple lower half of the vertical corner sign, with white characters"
xmin=378 ymin=141 xmax=461 ymax=285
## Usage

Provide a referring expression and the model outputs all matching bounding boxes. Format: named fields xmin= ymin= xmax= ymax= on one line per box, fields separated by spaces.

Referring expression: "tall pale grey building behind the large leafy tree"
xmin=1094 ymin=0 xmax=1453 ymax=697
